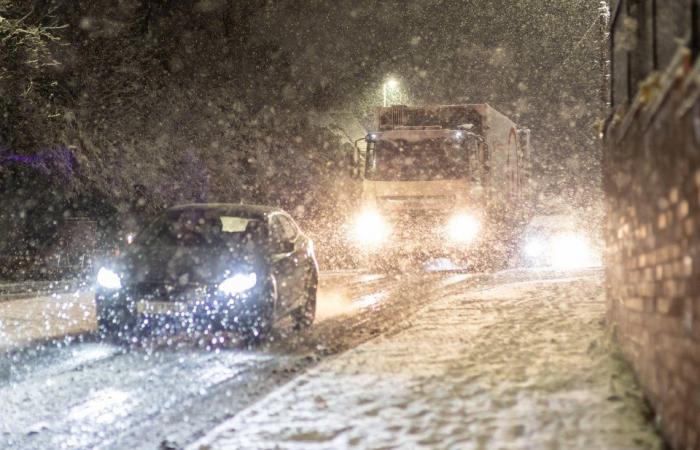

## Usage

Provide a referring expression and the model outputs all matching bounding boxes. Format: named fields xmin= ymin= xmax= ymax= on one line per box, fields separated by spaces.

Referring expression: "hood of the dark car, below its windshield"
xmin=121 ymin=246 xmax=264 ymax=286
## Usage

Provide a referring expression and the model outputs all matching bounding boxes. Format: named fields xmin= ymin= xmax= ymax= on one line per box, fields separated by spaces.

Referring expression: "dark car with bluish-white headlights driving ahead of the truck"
xmin=95 ymin=204 xmax=318 ymax=339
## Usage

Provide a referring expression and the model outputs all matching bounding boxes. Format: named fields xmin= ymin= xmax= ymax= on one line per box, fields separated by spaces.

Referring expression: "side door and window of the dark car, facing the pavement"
xmin=270 ymin=214 xmax=298 ymax=314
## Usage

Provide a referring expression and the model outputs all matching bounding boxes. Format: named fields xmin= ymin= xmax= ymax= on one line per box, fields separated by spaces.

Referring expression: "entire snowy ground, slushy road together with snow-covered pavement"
xmin=0 ymin=271 xmax=660 ymax=449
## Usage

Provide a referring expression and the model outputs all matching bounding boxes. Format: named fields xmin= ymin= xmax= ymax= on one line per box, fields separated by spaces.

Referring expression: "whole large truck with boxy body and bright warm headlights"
xmin=349 ymin=104 xmax=532 ymax=268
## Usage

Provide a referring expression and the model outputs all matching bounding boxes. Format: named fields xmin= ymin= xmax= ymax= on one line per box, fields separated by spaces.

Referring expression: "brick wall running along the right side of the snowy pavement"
xmin=603 ymin=49 xmax=700 ymax=449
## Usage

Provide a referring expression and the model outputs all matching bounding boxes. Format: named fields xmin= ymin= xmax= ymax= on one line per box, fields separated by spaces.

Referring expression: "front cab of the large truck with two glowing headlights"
xmin=353 ymin=127 xmax=488 ymax=265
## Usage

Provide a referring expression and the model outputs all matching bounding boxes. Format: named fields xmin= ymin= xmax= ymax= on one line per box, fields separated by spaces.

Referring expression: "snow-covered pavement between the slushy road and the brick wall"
xmin=190 ymin=271 xmax=662 ymax=449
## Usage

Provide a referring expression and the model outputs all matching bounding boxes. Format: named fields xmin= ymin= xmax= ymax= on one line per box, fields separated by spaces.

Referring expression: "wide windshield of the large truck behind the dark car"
xmin=366 ymin=138 xmax=469 ymax=181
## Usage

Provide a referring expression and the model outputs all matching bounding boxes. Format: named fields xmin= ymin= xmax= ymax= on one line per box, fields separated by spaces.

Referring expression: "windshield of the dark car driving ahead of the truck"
xmin=136 ymin=209 xmax=265 ymax=247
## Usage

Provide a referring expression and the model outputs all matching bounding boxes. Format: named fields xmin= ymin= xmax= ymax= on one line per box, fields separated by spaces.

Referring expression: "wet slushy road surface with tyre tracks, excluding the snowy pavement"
xmin=0 ymin=273 xmax=479 ymax=449
